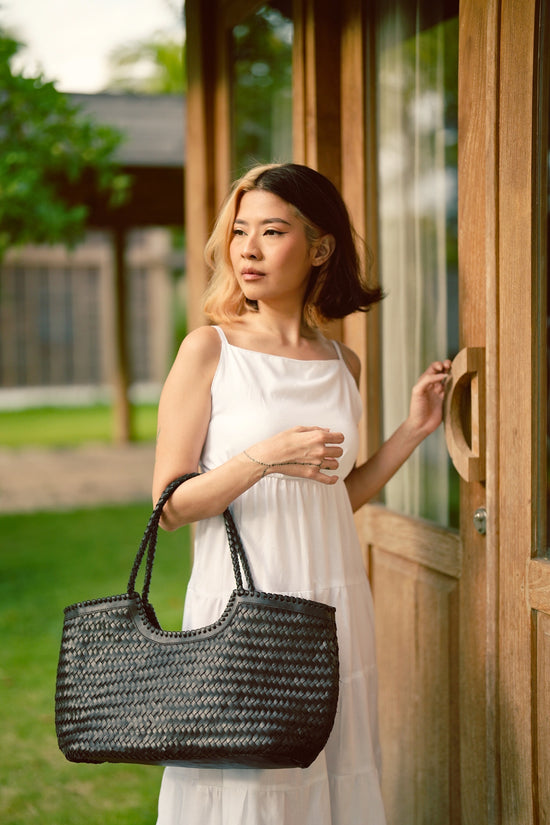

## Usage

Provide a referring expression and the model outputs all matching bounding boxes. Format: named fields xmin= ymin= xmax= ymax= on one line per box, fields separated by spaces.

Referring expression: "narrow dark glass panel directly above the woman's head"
xmin=232 ymin=2 xmax=294 ymax=176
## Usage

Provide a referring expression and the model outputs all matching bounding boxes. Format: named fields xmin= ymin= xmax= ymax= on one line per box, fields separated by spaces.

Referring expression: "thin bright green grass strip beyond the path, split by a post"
xmin=0 ymin=404 xmax=157 ymax=448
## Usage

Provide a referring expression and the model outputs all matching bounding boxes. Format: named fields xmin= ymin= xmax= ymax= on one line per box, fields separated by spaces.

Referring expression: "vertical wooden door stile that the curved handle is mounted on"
xmin=458 ymin=0 xmax=499 ymax=825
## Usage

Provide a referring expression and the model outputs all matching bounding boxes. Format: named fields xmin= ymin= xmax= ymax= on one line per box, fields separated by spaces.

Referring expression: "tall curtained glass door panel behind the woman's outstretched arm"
xmin=376 ymin=0 xmax=458 ymax=525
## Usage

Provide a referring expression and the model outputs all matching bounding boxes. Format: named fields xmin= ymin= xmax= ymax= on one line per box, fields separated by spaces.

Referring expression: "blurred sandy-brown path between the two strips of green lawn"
xmin=0 ymin=444 xmax=155 ymax=513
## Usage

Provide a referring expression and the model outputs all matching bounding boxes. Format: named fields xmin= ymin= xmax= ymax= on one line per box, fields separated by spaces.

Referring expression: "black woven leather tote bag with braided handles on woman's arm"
xmin=55 ymin=473 xmax=338 ymax=768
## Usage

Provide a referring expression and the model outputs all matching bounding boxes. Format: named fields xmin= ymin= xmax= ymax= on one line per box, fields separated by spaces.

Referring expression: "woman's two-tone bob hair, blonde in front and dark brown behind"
xmin=204 ymin=163 xmax=383 ymax=326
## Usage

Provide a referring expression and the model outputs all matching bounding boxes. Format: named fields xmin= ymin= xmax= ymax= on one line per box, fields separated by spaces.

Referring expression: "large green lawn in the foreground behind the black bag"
xmin=0 ymin=504 xmax=190 ymax=825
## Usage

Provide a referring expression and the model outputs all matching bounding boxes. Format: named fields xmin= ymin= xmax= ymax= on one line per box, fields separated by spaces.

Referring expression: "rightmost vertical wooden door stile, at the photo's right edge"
xmin=495 ymin=0 xmax=550 ymax=823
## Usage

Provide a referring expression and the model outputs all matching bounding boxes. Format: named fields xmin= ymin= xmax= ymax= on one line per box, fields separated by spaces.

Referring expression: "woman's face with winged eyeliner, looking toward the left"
xmin=229 ymin=189 xmax=322 ymax=308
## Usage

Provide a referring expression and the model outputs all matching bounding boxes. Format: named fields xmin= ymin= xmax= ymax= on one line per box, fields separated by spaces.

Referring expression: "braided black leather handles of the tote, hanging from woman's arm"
xmin=128 ymin=473 xmax=255 ymax=602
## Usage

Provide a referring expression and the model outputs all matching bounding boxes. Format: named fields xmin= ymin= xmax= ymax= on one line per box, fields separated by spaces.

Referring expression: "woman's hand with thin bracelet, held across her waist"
xmin=243 ymin=427 xmax=344 ymax=484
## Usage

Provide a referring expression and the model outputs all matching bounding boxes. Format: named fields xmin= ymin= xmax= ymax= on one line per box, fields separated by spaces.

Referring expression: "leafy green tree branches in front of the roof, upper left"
xmin=0 ymin=29 xmax=128 ymax=259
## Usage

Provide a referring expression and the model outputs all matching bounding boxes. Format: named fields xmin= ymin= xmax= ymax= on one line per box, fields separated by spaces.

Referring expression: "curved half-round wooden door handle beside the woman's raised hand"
xmin=443 ymin=347 xmax=485 ymax=481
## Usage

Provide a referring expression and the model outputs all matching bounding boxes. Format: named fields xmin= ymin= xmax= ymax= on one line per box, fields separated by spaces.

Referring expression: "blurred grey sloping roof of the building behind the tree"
xmin=69 ymin=93 xmax=185 ymax=168
